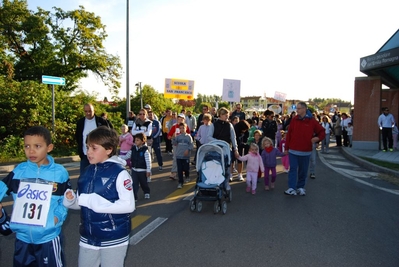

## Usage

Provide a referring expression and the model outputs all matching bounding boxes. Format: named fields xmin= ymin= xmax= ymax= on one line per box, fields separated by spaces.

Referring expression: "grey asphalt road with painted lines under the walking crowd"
xmin=0 ymin=149 xmax=399 ymax=267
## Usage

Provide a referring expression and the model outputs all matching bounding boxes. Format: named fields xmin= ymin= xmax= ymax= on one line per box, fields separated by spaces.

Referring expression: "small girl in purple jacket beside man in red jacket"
xmin=261 ymin=137 xmax=285 ymax=191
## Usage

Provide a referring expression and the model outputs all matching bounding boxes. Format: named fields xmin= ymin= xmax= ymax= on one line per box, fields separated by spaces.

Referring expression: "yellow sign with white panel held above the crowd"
xmin=164 ymin=78 xmax=194 ymax=100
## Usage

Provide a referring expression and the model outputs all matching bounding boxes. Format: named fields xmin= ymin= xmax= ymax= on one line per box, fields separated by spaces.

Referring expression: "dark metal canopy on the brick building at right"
xmin=360 ymin=30 xmax=399 ymax=88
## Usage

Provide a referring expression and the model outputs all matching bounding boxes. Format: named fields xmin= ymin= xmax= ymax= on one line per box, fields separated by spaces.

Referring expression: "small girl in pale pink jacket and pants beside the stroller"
xmin=237 ymin=143 xmax=265 ymax=195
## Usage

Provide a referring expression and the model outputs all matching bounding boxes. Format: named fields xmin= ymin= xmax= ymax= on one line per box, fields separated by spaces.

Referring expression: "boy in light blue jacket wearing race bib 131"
xmin=0 ymin=126 xmax=71 ymax=267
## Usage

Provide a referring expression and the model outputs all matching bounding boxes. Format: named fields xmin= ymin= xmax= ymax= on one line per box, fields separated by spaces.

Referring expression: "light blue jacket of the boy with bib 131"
xmin=0 ymin=155 xmax=71 ymax=244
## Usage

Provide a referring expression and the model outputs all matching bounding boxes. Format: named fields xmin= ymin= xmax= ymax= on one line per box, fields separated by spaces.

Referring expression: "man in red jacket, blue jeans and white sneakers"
xmin=284 ymin=102 xmax=326 ymax=196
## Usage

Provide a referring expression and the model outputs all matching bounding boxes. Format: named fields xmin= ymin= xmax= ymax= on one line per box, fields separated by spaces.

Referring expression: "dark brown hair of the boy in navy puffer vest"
xmin=86 ymin=126 xmax=119 ymax=157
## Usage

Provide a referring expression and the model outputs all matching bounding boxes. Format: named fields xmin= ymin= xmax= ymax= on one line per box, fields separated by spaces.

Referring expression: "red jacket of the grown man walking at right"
xmin=285 ymin=112 xmax=326 ymax=152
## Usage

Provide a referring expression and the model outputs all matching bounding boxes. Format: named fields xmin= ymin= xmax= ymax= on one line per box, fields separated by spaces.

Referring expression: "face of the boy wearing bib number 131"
xmin=24 ymin=135 xmax=53 ymax=167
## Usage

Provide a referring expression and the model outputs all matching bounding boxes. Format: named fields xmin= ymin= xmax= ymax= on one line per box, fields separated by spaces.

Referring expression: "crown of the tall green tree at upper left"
xmin=0 ymin=0 xmax=122 ymax=94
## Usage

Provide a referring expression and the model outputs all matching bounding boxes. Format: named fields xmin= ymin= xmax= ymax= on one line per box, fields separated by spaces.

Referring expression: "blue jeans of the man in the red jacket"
xmin=288 ymin=153 xmax=310 ymax=189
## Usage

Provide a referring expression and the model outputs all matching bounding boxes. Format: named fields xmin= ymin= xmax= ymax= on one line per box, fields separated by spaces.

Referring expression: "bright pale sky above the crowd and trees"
xmin=28 ymin=0 xmax=399 ymax=102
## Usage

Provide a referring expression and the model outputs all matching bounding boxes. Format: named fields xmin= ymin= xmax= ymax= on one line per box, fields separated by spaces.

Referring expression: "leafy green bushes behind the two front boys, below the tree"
xmin=0 ymin=77 xmax=124 ymax=161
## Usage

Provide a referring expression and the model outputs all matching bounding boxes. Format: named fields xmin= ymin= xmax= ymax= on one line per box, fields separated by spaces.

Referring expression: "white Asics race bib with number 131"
xmin=11 ymin=182 xmax=53 ymax=227
